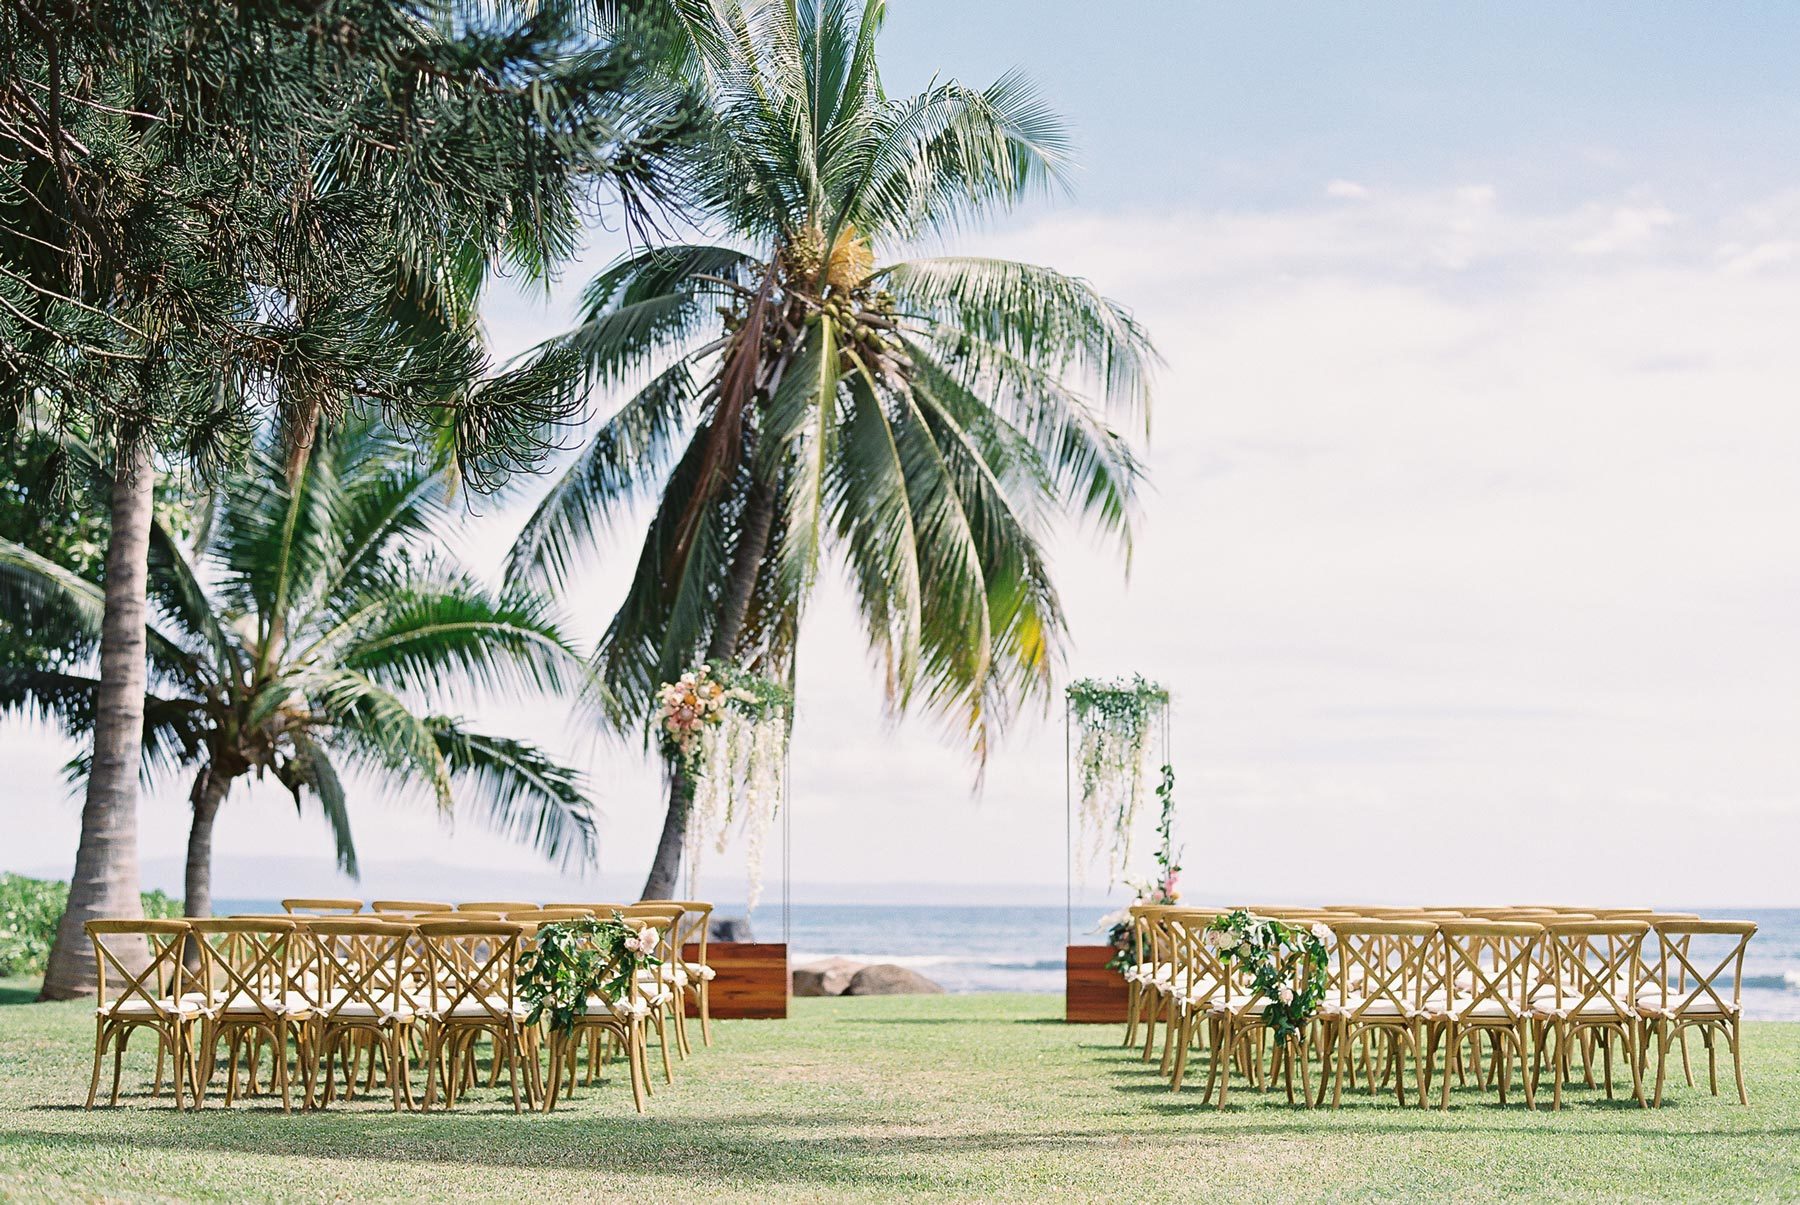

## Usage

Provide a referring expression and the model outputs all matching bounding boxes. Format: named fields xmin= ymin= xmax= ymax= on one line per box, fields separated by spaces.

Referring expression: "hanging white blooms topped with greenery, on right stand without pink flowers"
xmin=1067 ymin=674 xmax=1168 ymax=883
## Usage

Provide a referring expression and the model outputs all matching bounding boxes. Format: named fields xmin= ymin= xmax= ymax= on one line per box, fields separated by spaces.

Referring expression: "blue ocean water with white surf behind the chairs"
xmin=218 ymin=899 xmax=1800 ymax=1021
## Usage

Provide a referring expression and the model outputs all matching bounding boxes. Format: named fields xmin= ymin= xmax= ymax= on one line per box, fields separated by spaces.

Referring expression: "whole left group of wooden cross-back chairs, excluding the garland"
xmin=88 ymin=899 xmax=713 ymax=1111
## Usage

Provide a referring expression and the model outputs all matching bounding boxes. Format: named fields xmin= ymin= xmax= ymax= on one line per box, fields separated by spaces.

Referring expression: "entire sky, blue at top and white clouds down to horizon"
xmin=10 ymin=0 xmax=1800 ymax=906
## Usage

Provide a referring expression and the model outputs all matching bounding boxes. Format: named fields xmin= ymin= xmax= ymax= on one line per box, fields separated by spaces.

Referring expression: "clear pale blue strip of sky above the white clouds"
xmin=884 ymin=0 xmax=1800 ymax=209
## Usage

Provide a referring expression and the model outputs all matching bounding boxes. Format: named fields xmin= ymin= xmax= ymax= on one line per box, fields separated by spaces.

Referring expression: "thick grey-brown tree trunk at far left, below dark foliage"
xmin=41 ymin=439 xmax=157 ymax=1000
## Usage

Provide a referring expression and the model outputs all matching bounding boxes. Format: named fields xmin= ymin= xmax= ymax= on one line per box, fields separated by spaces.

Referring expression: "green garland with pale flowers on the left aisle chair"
xmin=518 ymin=913 xmax=662 ymax=1034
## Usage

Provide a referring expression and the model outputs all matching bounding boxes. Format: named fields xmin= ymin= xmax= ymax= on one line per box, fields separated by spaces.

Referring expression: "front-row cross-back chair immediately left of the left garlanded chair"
xmin=418 ymin=917 xmax=536 ymax=1113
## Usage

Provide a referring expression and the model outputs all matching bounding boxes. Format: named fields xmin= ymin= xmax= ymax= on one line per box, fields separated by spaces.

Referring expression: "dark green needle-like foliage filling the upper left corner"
xmin=0 ymin=0 xmax=691 ymax=485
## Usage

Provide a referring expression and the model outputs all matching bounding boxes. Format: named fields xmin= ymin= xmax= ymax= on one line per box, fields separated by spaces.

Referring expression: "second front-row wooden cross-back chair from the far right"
xmin=1532 ymin=919 xmax=1651 ymax=1110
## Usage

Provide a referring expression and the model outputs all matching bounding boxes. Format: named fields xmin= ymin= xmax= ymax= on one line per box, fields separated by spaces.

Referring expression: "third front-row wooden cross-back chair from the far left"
xmin=308 ymin=919 xmax=425 ymax=1111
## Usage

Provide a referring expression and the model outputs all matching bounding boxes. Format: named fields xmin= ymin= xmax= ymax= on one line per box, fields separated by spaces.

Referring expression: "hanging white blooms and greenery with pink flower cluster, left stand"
xmin=657 ymin=665 xmax=794 ymax=908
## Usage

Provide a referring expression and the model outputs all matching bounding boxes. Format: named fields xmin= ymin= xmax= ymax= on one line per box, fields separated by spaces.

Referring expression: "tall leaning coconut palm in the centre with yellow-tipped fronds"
xmin=513 ymin=0 xmax=1154 ymax=897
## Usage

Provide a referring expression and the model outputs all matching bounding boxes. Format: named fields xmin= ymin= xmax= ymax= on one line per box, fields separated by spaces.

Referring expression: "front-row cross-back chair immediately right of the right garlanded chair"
xmin=1319 ymin=917 xmax=1438 ymax=1108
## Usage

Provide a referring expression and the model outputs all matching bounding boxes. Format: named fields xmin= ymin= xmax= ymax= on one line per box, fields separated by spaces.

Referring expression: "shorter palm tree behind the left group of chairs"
xmin=0 ymin=423 xmax=594 ymax=917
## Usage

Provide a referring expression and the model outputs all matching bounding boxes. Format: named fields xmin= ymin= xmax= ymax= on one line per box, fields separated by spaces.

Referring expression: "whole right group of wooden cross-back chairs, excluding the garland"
xmin=1125 ymin=904 xmax=1757 ymax=1108
